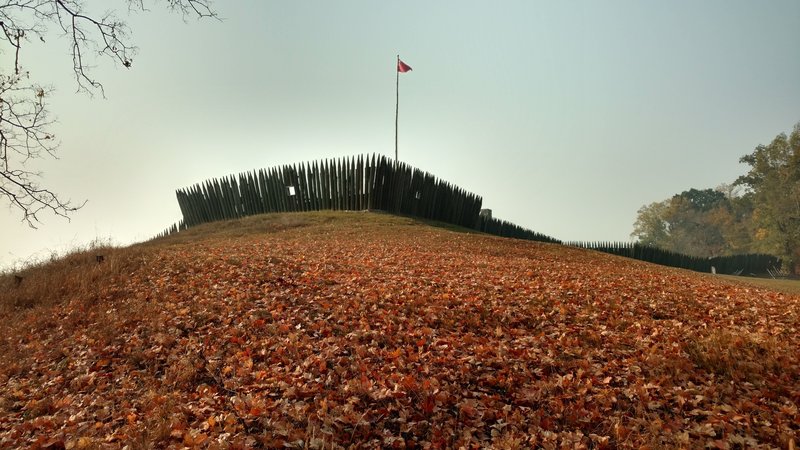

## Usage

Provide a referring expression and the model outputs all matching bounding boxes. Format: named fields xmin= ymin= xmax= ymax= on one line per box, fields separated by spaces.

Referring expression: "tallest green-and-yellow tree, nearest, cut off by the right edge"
xmin=736 ymin=122 xmax=800 ymax=275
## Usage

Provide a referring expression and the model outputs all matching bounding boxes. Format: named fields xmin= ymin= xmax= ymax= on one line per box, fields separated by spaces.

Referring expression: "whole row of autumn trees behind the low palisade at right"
xmin=631 ymin=122 xmax=800 ymax=275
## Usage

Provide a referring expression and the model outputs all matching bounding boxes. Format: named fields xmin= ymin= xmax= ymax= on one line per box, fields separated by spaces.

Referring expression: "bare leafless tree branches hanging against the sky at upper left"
xmin=0 ymin=0 xmax=216 ymax=228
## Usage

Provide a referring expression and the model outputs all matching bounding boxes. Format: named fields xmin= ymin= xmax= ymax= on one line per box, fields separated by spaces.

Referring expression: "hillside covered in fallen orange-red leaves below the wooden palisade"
xmin=0 ymin=212 xmax=800 ymax=449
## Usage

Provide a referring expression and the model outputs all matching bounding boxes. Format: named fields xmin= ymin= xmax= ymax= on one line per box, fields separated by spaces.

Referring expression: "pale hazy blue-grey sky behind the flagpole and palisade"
xmin=0 ymin=0 xmax=800 ymax=270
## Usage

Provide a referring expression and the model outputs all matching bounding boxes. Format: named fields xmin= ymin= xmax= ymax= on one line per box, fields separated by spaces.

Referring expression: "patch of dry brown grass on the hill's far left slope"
xmin=0 ymin=245 xmax=158 ymax=398
